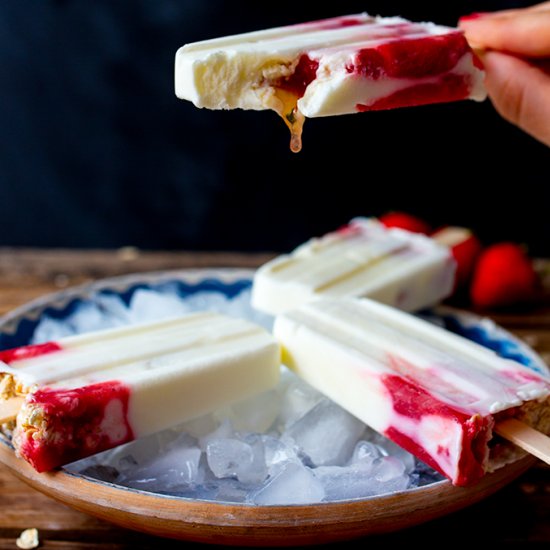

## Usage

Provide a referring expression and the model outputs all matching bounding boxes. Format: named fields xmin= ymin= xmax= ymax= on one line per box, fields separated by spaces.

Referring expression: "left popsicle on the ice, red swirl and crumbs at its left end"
xmin=0 ymin=312 xmax=280 ymax=472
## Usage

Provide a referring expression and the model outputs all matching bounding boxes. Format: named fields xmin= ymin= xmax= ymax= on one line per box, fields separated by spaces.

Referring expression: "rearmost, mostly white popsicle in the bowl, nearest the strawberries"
xmin=251 ymin=218 xmax=456 ymax=315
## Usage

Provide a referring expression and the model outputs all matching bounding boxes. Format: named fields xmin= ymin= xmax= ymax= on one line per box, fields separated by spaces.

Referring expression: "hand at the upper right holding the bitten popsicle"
xmin=459 ymin=2 xmax=550 ymax=146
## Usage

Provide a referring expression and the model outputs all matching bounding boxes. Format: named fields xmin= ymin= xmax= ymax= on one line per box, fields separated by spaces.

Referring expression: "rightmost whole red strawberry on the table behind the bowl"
xmin=470 ymin=242 xmax=540 ymax=309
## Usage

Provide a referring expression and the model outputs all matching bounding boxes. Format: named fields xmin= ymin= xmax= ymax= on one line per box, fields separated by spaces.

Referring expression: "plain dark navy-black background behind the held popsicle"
xmin=0 ymin=0 xmax=550 ymax=256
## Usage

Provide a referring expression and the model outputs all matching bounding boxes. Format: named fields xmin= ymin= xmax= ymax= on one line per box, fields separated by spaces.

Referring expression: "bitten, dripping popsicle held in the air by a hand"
xmin=175 ymin=13 xmax=486 ymax=152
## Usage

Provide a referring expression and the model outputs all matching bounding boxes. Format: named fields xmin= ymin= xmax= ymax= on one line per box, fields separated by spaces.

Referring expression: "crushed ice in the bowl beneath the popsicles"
xmin=34 ymin=287 xmax=441 ymax=505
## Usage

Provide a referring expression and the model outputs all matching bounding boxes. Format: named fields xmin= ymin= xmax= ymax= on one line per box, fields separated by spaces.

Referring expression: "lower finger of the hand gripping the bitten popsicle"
xmin=482 ymin=52 xmax=550 ymax=146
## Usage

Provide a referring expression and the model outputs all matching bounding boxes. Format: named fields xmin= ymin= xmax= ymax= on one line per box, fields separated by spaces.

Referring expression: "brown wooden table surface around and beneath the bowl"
xmin=0 ymin=248 xmax=550 ymax=550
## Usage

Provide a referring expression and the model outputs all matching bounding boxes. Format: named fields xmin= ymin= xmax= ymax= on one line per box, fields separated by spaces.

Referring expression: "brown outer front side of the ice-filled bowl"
xmin=0 ymin=440 xmax=536 ymax=546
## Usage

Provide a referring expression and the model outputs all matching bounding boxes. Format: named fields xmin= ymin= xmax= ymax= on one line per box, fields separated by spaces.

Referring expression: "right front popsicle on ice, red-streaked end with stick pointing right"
xmin=274 ymin=298 xmax=550 ymax=485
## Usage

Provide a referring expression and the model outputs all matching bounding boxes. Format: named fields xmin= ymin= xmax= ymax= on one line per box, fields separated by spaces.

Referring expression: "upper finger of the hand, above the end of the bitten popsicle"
xmin=459 ymin=9 xmax=550 ymax=58
